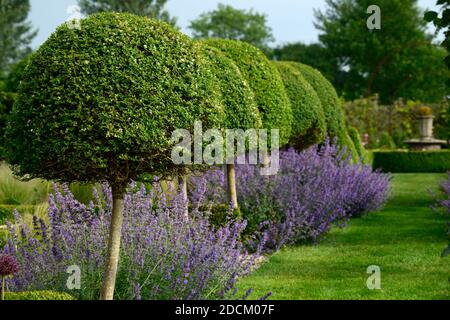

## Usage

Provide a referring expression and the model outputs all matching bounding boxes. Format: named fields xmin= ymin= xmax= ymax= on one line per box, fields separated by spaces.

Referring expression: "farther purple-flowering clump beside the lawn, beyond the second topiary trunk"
xmin=190 ymin=141 xmax=390 ymax=250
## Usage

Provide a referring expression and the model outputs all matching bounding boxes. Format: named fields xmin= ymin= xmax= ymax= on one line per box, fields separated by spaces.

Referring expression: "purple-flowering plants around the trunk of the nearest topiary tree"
xmin=3 ymin=184 xmax=262 ymax=299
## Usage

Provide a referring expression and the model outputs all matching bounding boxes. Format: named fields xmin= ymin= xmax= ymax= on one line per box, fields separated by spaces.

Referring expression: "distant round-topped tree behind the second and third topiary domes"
xmin=189 ymin=4 xmax=274 ymax=52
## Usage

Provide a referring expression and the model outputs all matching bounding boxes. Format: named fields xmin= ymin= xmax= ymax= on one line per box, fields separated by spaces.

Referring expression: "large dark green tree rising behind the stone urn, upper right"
xmin=316 ymin=0 xmax=448 ymax=103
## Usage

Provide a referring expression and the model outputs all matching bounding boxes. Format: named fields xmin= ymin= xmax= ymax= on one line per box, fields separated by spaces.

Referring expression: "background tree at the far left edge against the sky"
xmin=0 ymin=0 xmax=37 ymax=78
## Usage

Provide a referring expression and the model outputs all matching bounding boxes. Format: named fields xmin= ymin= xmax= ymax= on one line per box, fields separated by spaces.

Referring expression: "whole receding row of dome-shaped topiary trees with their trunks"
xmin=5 ymin=13 xmax=362 ymax=299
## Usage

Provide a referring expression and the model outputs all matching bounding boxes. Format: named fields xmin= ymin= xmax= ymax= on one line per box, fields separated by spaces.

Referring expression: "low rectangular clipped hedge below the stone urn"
xmin=373 ymin=150 xmax=450 ymax=173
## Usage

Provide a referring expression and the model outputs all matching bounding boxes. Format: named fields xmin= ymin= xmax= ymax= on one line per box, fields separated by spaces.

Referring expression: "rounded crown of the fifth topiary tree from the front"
xmin=291 ymin=62 xmax=345 ymax=139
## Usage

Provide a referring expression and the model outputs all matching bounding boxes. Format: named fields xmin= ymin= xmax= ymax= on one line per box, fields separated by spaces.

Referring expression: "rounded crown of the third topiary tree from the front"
xmin=205 ymin=39 xmax=293 ymax=145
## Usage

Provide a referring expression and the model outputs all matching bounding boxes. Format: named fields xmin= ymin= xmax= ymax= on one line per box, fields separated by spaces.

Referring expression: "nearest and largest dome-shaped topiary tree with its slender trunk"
xmin=6 ymin=13 xmax=222 ymax=300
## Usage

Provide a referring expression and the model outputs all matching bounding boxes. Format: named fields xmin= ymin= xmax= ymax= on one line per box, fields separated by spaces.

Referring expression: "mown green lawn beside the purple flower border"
xmin=239 ymin=174 xmax=450 ymax=300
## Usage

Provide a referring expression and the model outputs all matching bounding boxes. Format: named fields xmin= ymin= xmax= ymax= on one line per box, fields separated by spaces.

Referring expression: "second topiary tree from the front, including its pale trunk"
xmin=200 ymin=41 xmax=262 ymax=209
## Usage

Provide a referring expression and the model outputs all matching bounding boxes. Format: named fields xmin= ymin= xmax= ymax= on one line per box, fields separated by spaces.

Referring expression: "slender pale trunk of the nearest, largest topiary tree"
xmin=100 ymin=187 xmax=124 ymax=300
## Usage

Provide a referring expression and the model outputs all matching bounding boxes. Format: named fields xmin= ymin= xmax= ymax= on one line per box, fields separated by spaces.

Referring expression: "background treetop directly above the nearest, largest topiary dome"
xmin=78 ymin=0 xmax=177 ymax=26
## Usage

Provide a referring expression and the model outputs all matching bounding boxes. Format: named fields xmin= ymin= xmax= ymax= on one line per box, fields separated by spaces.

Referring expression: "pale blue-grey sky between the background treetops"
xmin=30 ymin=0 xmax=446 ymax=48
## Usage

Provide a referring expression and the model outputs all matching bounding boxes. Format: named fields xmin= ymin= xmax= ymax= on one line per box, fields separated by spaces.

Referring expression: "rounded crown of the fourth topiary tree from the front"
xmin=274 ymin=61 xmax=327 ymax=150
